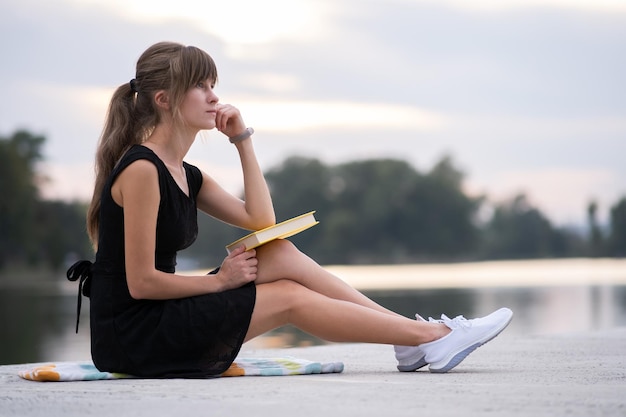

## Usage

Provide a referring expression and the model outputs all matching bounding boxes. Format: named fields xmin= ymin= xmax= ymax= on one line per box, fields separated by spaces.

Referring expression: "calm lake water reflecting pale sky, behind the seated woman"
xmin=0 ymin=259 xmax=626 ymax=365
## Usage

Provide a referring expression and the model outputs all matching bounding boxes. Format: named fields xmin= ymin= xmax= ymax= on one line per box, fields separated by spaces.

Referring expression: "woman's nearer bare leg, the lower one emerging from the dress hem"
xmin=246 ymin=279 xmax=450 ymax=346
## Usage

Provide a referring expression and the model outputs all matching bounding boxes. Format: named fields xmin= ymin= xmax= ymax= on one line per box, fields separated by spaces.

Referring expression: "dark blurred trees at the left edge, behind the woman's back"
xmin=0 ymin=130 xmax=92 ymax=271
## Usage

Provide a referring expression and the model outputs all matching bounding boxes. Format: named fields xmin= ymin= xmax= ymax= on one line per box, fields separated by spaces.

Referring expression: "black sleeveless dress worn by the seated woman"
xmin=90 ymin=145 xmax=256 ymax=377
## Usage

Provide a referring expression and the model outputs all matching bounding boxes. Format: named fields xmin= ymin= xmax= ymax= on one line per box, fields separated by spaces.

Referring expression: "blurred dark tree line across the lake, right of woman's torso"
xmin=189 ymin=157 xmax=626 ymax=264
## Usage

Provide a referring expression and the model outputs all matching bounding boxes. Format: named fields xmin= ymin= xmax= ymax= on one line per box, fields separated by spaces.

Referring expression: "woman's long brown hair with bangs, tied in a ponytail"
xmin=87 ymin=42 xmax=217 ymax=249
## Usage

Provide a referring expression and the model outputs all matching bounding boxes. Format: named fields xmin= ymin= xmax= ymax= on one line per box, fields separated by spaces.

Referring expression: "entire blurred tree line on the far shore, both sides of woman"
xmin=0 ymin=131 xmax=626 ymax=268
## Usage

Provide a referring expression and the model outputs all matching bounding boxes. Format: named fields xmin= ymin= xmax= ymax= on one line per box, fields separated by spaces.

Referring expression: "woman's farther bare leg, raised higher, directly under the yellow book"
xmin=256 ymin=240 xmax=399 ymax=316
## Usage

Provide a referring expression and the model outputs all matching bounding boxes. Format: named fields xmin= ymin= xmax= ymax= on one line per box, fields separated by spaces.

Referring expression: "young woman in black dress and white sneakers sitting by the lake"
xmin=68 ymin=42 xmax=512 ymax=377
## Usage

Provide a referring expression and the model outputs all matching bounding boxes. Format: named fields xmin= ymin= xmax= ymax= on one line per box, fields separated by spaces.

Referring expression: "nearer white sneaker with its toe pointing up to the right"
xmin=420 ymin=308 xmax=513 ymax=373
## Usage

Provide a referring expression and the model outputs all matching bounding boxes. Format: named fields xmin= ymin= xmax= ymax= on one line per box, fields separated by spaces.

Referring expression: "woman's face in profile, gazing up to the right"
xmin=180 ymin=80 xmax=219 ymax=130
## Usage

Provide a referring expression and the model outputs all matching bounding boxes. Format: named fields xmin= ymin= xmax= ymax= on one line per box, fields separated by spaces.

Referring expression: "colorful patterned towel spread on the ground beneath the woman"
xmin=18 ymin=357 xmax=343 ymax=382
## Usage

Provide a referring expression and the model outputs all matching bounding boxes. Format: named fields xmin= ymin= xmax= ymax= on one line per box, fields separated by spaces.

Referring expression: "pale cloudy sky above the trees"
xmin=0 ymin=0 xmax=626 ymax=225
